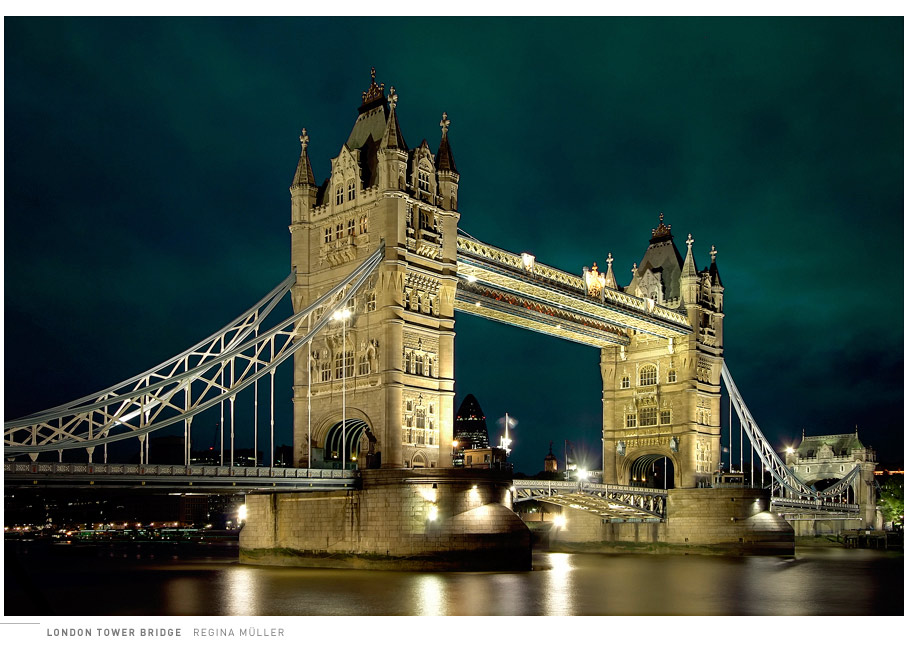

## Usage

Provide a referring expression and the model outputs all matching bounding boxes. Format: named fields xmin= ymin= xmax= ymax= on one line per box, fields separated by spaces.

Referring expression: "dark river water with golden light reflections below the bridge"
xmin=4 ymin=542 xmax=904 ymax=616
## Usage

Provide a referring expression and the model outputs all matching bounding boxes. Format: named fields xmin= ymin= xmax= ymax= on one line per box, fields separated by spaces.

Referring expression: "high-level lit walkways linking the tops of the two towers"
xmin=455 ymin=235 xmax=691 ymax=347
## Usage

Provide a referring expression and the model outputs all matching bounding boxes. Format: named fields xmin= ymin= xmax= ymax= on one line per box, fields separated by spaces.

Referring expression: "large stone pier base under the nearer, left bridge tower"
xmin=240 ymin=469 xmax=531 ymax=569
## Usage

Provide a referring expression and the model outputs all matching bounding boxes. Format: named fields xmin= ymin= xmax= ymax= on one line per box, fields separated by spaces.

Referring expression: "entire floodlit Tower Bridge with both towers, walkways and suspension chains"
xmin=4 ymin=70 xmax=866 ymax=564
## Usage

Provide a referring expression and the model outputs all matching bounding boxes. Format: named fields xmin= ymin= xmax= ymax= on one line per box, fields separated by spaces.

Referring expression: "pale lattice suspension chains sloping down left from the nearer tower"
xmin=4 ymin=243 xmax=384 ymax=456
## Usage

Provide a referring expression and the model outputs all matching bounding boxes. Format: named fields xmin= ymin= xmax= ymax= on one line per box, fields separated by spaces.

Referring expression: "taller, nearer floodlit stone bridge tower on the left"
xmin=290 ymin=68 xmax=460 ymax=469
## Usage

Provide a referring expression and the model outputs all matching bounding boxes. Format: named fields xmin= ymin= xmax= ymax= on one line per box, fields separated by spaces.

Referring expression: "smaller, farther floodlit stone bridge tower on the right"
xmin=600 ymin=214 xmax=724 ymax=487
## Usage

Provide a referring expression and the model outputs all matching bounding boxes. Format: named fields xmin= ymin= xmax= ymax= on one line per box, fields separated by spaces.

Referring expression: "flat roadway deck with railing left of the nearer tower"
xmin=3 ymin=462 xmax=357 ymax=494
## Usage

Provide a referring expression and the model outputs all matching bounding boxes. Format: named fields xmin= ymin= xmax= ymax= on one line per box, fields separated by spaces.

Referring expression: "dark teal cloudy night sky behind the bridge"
xmin=4 ymin=17 xmax=904 ymax=474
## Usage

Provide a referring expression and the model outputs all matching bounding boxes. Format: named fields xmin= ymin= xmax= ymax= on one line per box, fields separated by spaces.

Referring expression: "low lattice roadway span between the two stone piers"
xmin=514 ymin=480 xmax=668 ymax=519
